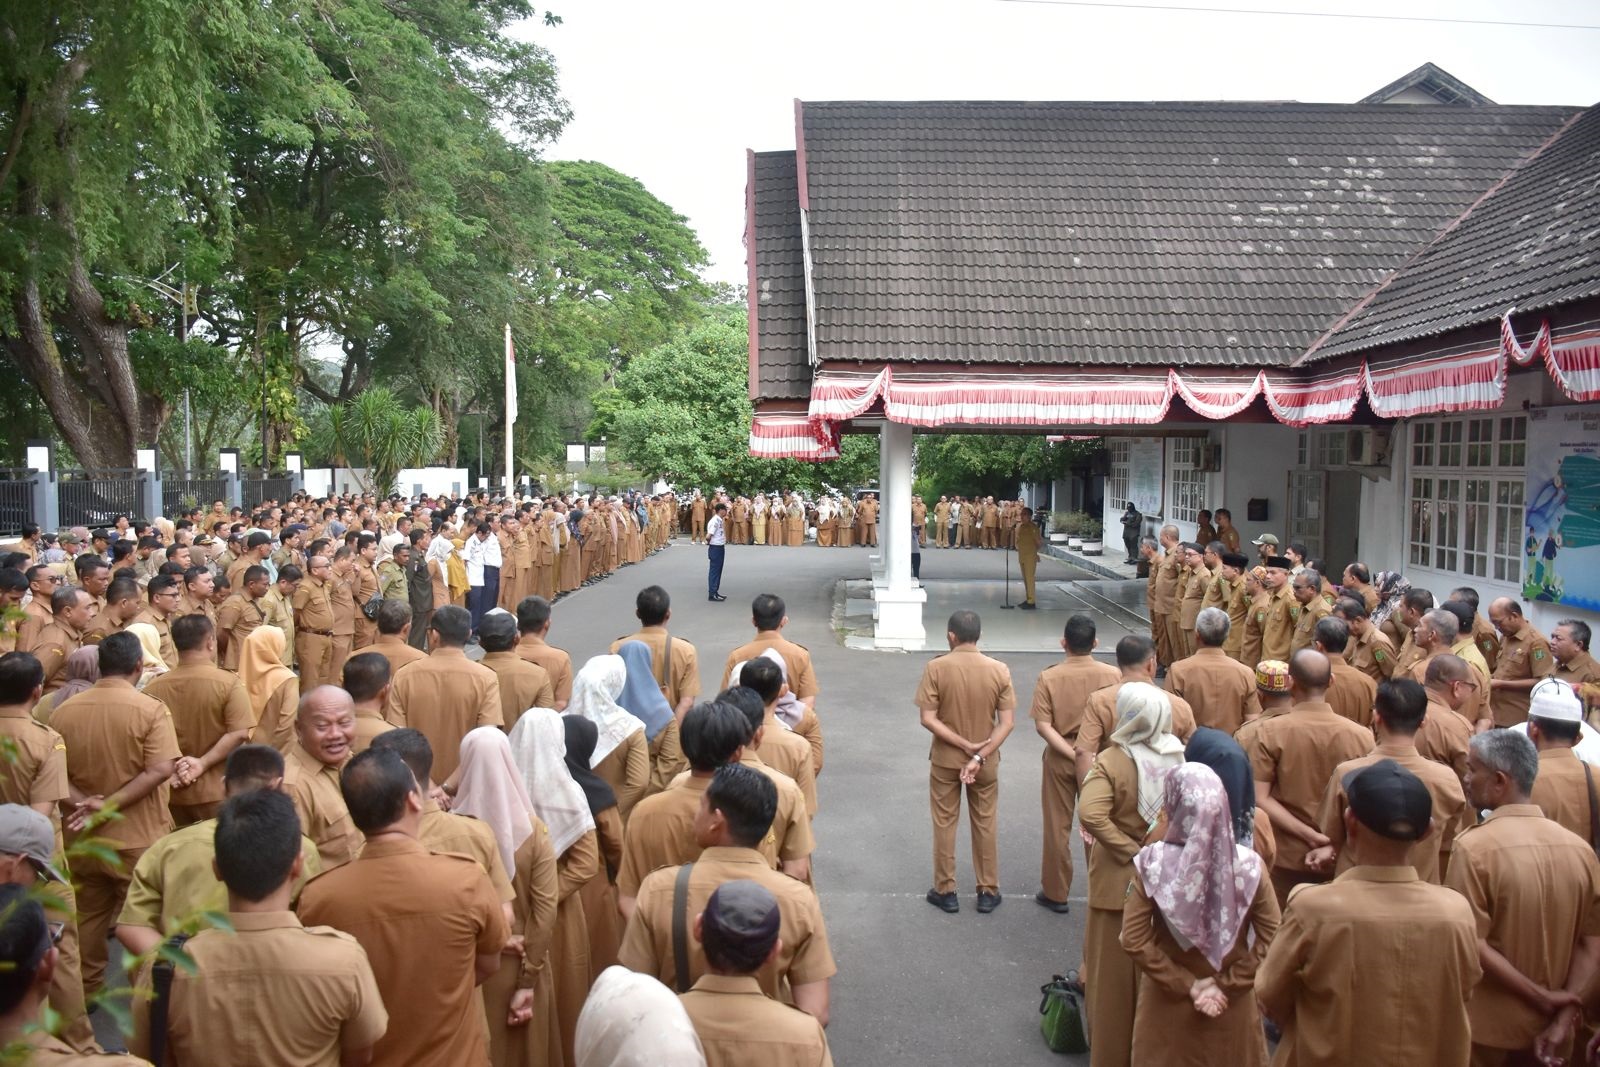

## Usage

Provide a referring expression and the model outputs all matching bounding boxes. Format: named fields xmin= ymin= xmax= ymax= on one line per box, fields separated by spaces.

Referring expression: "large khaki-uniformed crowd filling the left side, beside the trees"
xmin=0 ymin=496 xmax=835 ymax=1067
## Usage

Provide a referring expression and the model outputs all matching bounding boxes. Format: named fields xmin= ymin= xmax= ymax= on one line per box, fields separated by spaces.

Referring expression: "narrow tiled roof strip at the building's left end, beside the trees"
xmin=746 ymin=152 xmax=811 ymax=400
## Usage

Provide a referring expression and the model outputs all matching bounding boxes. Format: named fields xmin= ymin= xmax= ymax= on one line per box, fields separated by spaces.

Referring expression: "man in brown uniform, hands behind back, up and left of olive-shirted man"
xmin=50 ymin=633 xmax=182 ymax=993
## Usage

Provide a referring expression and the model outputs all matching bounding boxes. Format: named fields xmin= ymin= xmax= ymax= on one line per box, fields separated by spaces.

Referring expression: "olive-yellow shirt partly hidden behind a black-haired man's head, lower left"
xmin=117 ymin=819 xmax=322 ymax=934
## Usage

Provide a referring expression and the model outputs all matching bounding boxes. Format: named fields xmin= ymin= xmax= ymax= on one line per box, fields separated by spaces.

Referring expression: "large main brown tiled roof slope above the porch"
xmin=793 ymin=102 xmax=1573 ymax=367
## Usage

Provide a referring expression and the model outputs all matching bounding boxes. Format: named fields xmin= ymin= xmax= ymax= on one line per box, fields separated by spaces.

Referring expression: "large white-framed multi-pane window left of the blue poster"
xmin=1406 ymin=414 xmax=1528 ymax=584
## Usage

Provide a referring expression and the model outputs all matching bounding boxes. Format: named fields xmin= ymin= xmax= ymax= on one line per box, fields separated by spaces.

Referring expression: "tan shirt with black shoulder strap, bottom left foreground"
xmin=168 ymin=912 xmax=389 ymax=1067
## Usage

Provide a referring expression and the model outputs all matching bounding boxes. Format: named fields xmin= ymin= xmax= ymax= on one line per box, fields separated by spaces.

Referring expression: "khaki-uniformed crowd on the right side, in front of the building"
xmin=917 ymin=510 xmax=1600 ymax=1067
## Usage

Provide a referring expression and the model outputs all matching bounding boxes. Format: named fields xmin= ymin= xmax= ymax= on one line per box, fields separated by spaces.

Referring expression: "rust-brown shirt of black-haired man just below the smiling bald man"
xmin=299 ymin=835 xmax=510 ymax=1067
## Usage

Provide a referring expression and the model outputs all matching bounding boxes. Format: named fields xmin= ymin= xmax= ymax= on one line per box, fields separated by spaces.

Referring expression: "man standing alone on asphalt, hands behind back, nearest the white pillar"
xmin=915 ymin=611 xmax=1016 ymax=913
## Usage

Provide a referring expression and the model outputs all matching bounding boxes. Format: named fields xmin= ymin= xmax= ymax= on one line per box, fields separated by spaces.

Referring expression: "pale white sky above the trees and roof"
xmin=520 ymin=0 xmax=1600 ymax=283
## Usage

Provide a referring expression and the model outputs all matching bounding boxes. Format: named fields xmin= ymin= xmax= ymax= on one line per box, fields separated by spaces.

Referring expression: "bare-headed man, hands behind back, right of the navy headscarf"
xmin=1245 ymin=648 xmax=1373 ymax=901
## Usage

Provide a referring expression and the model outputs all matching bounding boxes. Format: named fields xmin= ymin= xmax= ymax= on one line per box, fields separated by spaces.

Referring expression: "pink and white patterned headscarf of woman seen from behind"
xmin=1133 ymin=763 xmax=1261 ymax=971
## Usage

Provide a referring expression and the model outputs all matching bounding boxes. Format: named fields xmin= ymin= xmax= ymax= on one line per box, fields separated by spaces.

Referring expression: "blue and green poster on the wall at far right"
xmin=1522 ymin=405 xmax=1600 ymax=611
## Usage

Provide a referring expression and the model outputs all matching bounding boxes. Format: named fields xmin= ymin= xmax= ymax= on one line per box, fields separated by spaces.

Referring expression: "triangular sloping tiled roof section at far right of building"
xmin=1307 ymin=107 xmax=1600 ymax=362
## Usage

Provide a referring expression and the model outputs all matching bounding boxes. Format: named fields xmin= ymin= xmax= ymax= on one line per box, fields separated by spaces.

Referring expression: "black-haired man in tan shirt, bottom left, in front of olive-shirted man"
xmin=168 ymin=789 xmax=389 ymax=1064
